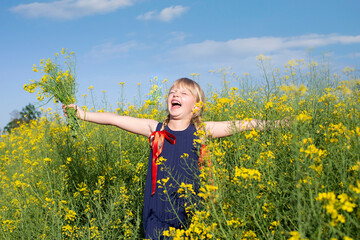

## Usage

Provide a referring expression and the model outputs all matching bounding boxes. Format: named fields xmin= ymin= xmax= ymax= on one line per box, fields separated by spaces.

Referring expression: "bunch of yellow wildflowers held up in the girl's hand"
xmin=24 ymin=48 xmax=80 ymax=137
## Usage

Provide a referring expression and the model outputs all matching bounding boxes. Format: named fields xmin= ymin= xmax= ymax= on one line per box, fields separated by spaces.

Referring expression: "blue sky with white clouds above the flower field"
xmin=0 ymin=0 xmax=360 ymax=128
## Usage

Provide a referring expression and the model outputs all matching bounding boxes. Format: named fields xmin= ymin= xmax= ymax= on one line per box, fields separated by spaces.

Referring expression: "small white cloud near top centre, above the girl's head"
xmin=137 ymin=5 xmax=188 ymax=22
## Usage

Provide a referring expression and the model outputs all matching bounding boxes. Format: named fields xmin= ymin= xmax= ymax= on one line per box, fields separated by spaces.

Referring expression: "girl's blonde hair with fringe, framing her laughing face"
xmin=160 ymin=78 xmax=205 ymax=131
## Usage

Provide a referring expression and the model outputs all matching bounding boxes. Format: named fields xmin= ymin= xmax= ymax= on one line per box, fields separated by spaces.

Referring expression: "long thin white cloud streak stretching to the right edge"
xmin=170 ymin=34 xmax=360 ymax=60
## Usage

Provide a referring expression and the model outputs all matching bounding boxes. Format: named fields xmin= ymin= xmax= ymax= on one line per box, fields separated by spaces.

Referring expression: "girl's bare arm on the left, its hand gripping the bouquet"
xmin=63 ymin=104 xmax=158 ymax=137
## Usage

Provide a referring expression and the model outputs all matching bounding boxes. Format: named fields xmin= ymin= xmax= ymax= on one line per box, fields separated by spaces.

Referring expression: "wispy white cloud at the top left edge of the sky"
xmin=11 ymin=0 xmax=134 ymax=20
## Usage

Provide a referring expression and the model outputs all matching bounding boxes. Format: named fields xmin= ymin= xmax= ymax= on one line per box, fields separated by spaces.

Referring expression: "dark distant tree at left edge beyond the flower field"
xmin=4 ymin=103 xmax=41 ymax=133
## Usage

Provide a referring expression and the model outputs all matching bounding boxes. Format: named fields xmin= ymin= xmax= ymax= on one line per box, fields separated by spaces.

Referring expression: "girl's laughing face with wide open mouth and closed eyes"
xmin=167 ymin=85 xmax=196 ymax=121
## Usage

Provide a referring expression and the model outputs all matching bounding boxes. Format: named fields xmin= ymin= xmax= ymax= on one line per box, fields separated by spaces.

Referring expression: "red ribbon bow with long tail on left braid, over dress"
xmin=149 ymin=130 xmax=176 ymax=195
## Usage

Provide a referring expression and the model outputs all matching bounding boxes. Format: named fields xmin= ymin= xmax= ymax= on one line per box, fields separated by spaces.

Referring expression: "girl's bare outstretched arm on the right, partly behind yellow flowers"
xmin=205 ymin=118 xmax=290 ymax=138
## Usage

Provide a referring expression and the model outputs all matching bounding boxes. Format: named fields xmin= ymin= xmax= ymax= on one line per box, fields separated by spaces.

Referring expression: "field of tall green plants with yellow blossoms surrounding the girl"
xmin=0 ymin=56 xmax=360 ymax=239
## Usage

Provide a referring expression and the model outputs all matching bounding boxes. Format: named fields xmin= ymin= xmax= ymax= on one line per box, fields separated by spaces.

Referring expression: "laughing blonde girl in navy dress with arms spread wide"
xmin=63 ymin=78 xmax=281 ymax=239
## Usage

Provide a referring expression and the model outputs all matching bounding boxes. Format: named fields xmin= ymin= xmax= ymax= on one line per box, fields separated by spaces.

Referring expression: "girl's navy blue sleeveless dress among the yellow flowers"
xmin=143 ymin=123 xmax=199 ymax=239
